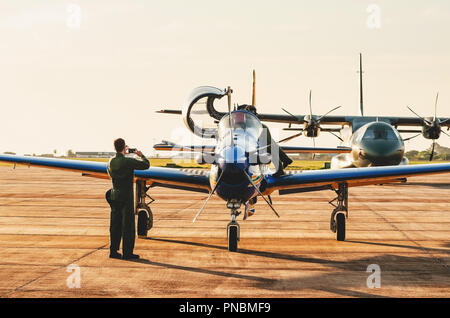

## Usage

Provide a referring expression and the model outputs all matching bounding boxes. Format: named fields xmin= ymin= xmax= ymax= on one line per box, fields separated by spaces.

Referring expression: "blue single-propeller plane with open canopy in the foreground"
xmin=0 ymin=87 xmax=450 ymax=251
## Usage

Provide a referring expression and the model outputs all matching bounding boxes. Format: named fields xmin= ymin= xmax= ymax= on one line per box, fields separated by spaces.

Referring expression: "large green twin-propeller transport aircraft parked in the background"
xmin=159 ymin=54 xmax=450 ymax=169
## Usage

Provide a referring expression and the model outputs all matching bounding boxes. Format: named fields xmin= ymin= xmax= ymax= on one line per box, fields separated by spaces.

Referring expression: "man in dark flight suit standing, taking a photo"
xmin=106 ymin=138 xmax=150 ymax=259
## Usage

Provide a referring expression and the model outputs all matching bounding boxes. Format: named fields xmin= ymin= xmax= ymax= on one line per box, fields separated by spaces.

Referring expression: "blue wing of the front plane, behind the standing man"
xmin=0 ymin=155 xmax=211 ymax=193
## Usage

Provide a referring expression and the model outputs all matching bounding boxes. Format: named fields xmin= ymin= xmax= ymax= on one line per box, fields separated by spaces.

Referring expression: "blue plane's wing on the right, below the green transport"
xmin=265 ymin=163 xmax=450 ymax=194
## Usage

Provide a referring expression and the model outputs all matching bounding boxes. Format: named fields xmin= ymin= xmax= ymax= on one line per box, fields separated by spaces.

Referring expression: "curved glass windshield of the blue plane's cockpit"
xmin=219 ymin=111 xmax=263 ymax=139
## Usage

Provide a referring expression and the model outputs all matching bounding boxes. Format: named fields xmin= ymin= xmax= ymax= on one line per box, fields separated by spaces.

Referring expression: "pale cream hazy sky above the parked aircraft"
xmin=0 ymin=0 xmax=450 ymax=155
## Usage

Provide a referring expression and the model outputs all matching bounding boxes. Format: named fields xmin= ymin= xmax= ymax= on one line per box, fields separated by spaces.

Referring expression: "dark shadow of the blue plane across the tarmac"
xmin=142 ymin=237 xmax=450 ymax=297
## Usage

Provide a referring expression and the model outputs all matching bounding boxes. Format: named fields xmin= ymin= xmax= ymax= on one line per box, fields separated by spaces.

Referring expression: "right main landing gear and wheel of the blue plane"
xmin=329 ymin=183 xmax=348 ymax=241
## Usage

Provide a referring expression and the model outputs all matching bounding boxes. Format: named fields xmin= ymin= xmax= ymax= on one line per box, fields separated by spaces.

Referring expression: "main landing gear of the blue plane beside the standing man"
xmin=134 ymin=180 xmax=155 ymax=238
